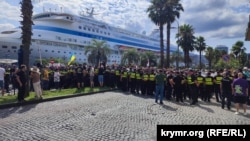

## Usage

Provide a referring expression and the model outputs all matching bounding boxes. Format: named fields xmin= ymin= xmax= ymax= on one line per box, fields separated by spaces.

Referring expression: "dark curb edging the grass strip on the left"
xmin=0 ymin=88 xmax=117 ymax=109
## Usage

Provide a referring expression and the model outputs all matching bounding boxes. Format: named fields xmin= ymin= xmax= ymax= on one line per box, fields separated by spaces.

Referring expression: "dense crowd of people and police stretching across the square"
xmin=0 ymin=63 xmax=250 ymax=114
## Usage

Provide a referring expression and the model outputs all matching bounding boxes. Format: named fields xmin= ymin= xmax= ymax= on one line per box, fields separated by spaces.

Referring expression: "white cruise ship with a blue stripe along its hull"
xmin=0 ymin=9 xmax=177 ymax=64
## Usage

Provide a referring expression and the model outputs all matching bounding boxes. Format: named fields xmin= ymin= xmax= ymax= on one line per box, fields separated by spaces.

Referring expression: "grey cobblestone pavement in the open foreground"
xmin=0 ymin=92 xmax=250 ymax=141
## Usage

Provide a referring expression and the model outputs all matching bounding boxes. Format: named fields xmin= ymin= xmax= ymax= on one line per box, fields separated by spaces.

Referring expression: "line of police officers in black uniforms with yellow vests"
xmin=36 ymin=66 xmax=250 ymax=104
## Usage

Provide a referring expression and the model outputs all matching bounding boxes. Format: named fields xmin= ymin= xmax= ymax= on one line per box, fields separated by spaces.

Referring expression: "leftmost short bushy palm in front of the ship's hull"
xmin=85 ymin=39 xmax=111 ymax=66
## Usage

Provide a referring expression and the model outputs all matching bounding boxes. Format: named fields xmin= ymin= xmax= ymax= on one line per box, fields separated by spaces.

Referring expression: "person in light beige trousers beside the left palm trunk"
xmin=30 ymin=67 xmax=42 ymax=99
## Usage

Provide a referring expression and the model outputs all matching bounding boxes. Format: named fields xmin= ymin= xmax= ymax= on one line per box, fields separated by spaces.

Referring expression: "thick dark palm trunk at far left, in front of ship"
xmin=19 ymin=0 xmax=33 ymax=96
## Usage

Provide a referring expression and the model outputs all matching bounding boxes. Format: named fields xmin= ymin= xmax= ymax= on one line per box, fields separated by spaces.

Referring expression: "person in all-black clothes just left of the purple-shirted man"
xmin=220 ymin=72 xmax=233 ymax=110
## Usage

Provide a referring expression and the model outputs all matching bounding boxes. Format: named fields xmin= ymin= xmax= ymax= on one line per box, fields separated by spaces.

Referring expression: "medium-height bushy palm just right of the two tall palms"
xmin=177 ymin=24 xmax=195 ymax=67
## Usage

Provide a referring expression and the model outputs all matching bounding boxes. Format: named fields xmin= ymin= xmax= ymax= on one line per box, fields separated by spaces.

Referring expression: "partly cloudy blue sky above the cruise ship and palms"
xmin=0 ymin=0 xmax=250 ymax=53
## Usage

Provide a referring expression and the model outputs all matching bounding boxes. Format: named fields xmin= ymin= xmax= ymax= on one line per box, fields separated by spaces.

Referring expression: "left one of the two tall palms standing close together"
xmin=147 ymin=0 xmax=167 ymax=68
